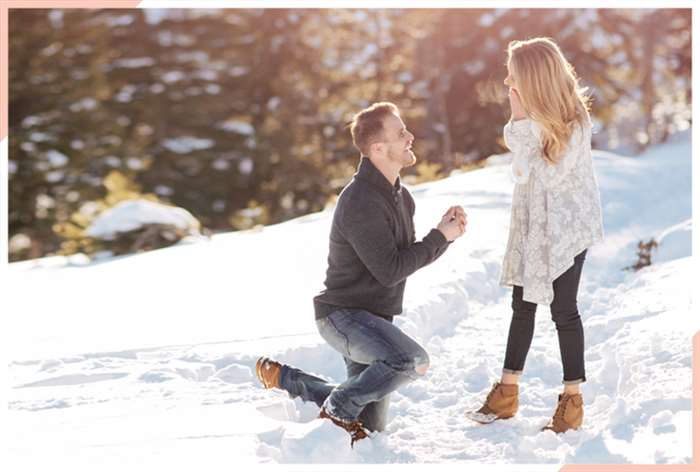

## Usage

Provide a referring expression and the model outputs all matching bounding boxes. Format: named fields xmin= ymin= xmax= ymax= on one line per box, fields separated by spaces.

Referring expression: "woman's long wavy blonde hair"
xmin=507 ymin=38 xmax=590 ymax=164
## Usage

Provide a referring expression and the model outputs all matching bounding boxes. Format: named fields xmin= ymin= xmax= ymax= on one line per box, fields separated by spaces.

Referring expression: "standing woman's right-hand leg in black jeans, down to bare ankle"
xmin=550 ymin=251 xmax=586 ymax=394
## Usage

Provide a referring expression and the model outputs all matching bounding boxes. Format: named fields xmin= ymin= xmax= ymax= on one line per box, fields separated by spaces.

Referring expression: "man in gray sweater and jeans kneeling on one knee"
xmin=256 ymin=102 xmax=467 ymax=445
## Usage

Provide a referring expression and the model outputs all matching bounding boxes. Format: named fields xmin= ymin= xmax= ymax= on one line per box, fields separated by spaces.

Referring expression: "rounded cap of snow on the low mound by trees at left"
xmin=85 ymin=199 xmax=199 ymax=239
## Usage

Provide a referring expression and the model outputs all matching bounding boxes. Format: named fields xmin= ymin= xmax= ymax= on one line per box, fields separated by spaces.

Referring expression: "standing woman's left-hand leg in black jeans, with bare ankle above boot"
xmin=501 ymin=285 xmax=537 ymax=384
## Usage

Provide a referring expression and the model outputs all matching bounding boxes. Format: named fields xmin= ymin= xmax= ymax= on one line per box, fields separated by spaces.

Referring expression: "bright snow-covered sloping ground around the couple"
xmin=8 ymin=133 xmax=698 ymax=470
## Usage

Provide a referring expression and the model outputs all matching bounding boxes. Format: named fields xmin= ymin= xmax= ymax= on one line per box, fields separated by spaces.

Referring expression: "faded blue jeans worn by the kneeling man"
xmin=280 ymin=309 xmax=430 ymax=431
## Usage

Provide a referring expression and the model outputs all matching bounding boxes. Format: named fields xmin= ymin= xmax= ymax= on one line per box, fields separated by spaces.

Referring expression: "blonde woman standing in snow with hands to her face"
xmin=467 ymin=38 xmax=603 ymax=433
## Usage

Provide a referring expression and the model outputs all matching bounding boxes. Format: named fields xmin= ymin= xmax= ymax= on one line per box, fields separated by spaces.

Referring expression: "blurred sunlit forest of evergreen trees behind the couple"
xmin=8 ymin=9 xmax=691 ymax=261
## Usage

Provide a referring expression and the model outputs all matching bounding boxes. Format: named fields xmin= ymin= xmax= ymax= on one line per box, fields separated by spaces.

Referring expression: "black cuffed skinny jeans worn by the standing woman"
xmin=503 ymin=250 xmax=586 ymax=384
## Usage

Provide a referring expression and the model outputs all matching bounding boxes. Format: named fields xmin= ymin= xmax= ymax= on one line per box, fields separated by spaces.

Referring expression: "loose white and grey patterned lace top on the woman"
xmin=500 ymin=119 xmax=603 ymax=305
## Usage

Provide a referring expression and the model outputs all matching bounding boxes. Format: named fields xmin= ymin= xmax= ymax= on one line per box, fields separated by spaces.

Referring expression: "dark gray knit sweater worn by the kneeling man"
xmin=314 ymin=157 xmax=449 ymax=319
